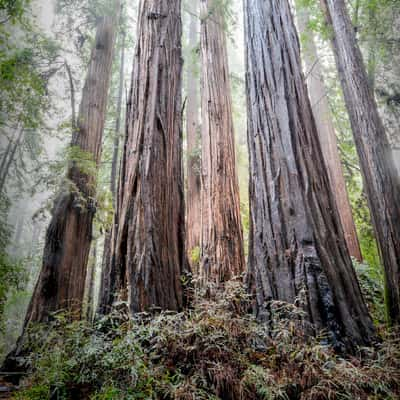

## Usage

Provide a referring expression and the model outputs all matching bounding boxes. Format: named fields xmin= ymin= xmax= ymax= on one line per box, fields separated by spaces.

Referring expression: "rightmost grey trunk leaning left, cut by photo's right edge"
xmin=321 ymin=0 xmax=400 ymax=324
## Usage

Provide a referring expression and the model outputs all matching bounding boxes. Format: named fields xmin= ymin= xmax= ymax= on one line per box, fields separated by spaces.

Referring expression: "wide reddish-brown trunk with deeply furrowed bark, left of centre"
xmin=106 ymin=0 xmax=186 ymax=312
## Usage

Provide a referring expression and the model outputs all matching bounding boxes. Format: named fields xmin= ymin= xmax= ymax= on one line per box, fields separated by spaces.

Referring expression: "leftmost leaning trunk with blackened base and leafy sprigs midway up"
xmin=25 ymin=16 xmax=116 ymax=324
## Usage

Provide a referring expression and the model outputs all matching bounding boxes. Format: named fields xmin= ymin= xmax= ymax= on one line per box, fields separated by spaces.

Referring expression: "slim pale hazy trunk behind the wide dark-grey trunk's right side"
xmin=298 ymin=7 xmax=362 ymax=262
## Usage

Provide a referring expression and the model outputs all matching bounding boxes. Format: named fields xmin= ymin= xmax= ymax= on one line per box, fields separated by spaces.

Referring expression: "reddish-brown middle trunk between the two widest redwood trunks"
xmin=200 ymin=0 xmax=245 ymax=284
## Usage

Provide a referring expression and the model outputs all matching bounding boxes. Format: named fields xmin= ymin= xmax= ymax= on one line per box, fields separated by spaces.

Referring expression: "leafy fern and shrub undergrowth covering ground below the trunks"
xmin=10 ymin=282 xmax=400 ymax=400
